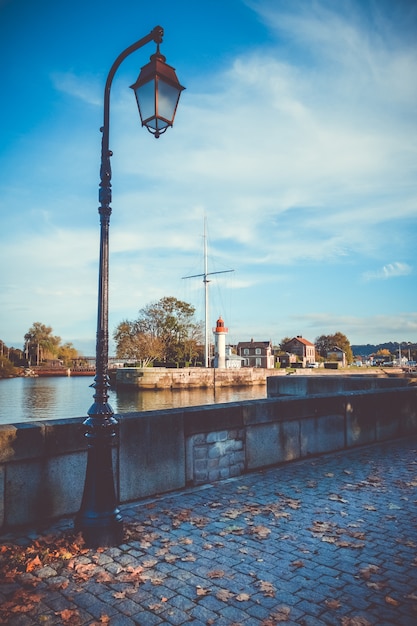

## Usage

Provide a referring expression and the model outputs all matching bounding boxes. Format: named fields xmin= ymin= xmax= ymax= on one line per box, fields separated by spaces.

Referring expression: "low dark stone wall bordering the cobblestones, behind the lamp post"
xmin=0 ymin=376 xmax=417 ymax=530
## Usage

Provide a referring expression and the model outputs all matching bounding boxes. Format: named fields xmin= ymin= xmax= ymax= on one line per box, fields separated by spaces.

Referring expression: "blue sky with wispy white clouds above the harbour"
xmin=0 ymin=0 xmax=417 ymax=355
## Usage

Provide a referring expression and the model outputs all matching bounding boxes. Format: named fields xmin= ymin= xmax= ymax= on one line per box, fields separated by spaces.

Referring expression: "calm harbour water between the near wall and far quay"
xmin=0 ymin=376 xmax=266 ymax=424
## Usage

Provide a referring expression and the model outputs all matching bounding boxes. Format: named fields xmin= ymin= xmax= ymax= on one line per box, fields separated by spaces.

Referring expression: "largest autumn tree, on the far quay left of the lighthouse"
xmin=113 ymin=297 xmax=202 ymax=364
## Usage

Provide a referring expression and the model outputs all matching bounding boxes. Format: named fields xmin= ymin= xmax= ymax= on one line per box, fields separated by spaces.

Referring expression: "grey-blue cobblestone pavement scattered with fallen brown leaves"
xmin=0 ymin=439 xmax=417 ymax=626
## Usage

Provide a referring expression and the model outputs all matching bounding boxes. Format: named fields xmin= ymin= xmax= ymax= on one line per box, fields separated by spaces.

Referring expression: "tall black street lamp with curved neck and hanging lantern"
xmin=75 ymin=26 xmax=184 ymax=548
